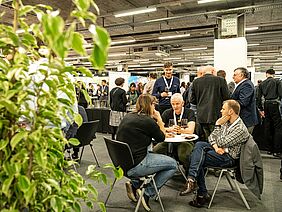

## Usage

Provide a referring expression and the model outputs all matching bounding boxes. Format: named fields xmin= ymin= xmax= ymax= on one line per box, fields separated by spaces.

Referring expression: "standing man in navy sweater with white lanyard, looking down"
xmin=153 ymin=62 xmax=180 ymax=114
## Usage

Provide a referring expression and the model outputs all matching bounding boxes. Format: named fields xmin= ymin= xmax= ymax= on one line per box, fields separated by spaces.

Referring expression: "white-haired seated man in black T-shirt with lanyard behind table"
xmin=153 ymin=93 xmax=195 ymax=170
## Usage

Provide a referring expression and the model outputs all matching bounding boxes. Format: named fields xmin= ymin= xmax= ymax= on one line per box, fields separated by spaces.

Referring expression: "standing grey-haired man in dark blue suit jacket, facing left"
xmin=231 ymin=67 xmax=258 ymax=134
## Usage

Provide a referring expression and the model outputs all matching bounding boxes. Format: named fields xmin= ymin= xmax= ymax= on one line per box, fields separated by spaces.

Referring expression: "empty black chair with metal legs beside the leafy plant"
xmin=75 ymin=120 xmax=100 ymax=167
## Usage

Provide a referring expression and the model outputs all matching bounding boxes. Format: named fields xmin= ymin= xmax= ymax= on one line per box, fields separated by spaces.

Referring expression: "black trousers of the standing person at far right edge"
xmin=264 ymin=101 xmax=282 ymax=153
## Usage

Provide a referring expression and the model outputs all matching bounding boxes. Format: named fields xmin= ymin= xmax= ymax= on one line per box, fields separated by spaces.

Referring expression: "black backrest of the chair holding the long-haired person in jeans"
xmin=104 ymin=137 xmax=134 ymax=176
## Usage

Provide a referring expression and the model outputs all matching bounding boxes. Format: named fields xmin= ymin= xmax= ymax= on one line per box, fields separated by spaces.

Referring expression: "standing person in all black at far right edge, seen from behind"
xmin=257 ymin=69 xmax=282 ymax=157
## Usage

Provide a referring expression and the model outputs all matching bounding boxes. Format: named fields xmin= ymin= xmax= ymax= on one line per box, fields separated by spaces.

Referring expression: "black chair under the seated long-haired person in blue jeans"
xmin=104 ymin=137 xmax=164 ymax=212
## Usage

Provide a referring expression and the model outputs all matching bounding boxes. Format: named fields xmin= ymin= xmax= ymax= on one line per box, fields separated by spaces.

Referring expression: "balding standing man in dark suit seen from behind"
xmin=190 ymin=66 xmax=229 ymax=140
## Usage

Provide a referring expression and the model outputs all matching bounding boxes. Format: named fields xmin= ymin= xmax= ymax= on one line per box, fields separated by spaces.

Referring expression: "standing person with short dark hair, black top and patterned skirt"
xmin=109 ymin=77 xmax=127 ymax=139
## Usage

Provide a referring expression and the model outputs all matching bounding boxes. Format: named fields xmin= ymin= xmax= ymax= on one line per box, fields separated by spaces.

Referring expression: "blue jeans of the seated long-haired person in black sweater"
xmin=127 ymin=152 xmax=177 ymax=197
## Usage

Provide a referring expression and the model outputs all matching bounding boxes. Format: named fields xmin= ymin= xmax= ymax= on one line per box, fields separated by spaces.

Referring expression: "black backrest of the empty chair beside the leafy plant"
xmin=75 ymin=120 xmax=100 ymax=146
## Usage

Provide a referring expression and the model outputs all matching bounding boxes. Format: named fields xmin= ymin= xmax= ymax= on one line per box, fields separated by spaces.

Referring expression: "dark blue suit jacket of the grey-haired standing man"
xmin=231 ymin=79 xmax=258 ymax=127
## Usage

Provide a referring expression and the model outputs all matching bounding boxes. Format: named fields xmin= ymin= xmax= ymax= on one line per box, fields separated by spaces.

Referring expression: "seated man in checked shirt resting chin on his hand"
xmin=180 ymin=100 xmax=249 ymax=207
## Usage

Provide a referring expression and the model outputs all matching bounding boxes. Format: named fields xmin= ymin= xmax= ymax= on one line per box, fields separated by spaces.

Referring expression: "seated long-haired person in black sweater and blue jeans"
xmin=117 ymin=94 xmax=177 ymax=211
